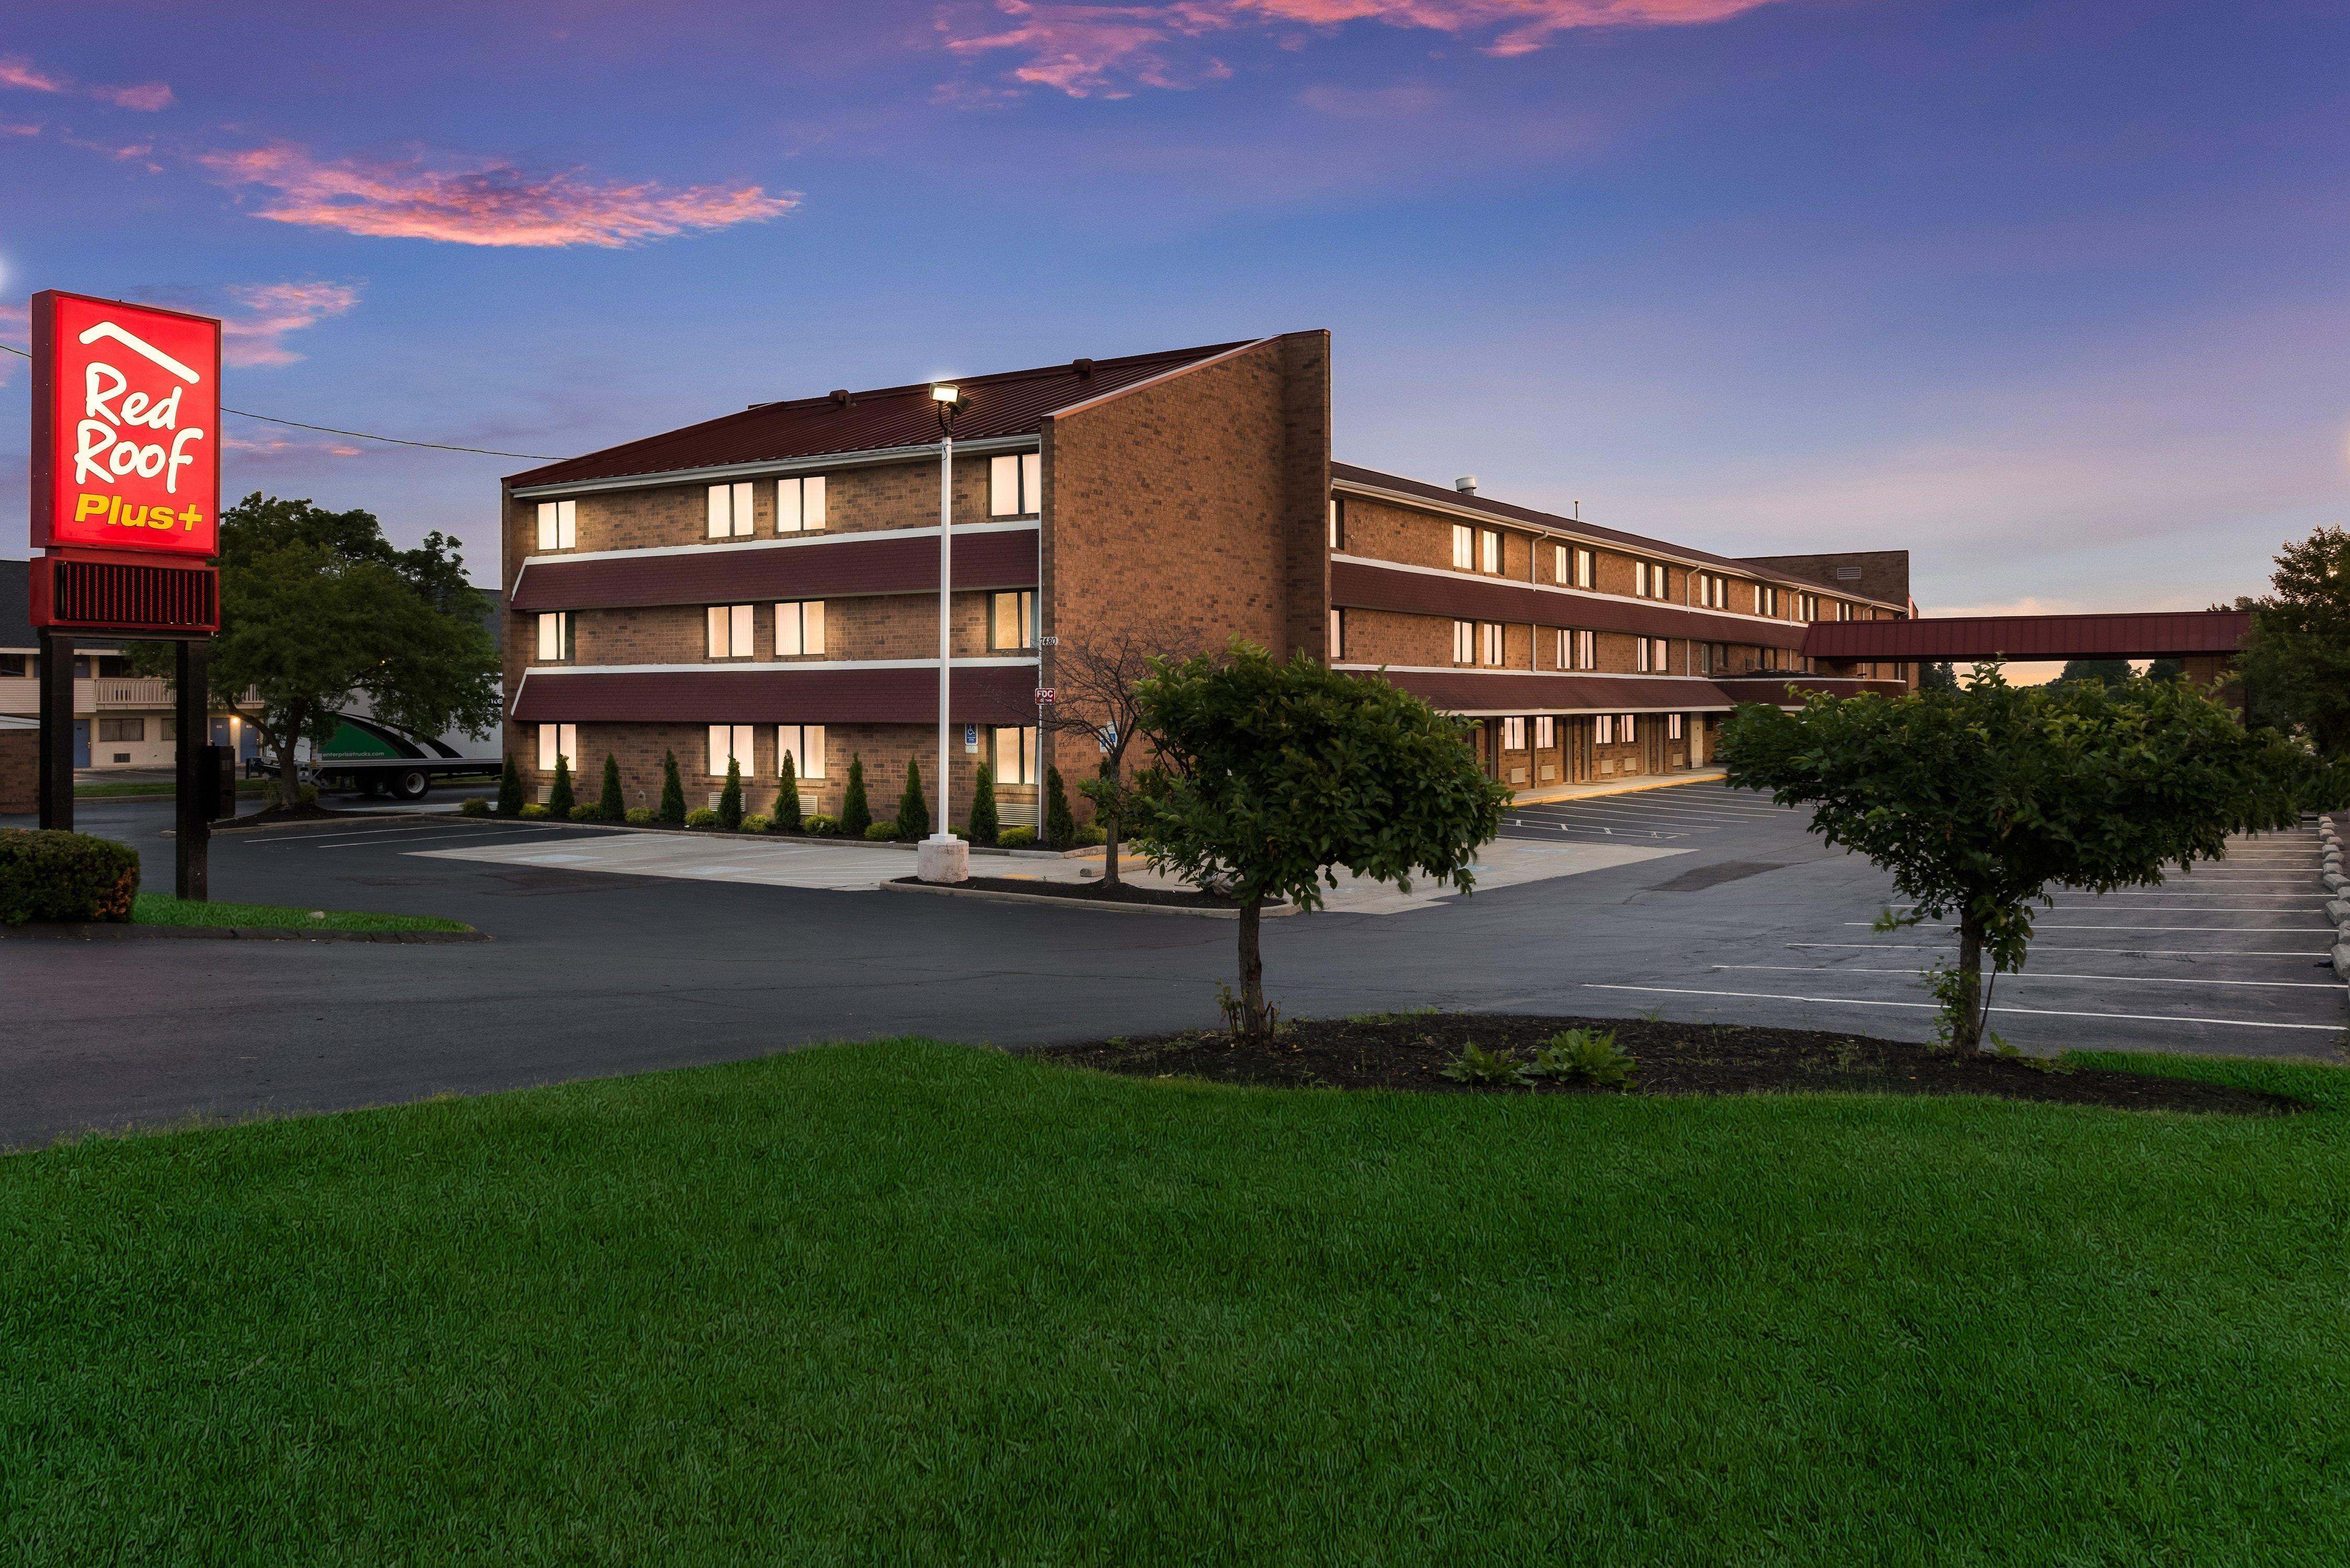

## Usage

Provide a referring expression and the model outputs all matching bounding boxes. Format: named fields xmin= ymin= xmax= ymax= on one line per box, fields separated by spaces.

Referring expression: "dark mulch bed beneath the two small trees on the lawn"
xmin=1039 ymin=1013 xmax=2306 ymax=1117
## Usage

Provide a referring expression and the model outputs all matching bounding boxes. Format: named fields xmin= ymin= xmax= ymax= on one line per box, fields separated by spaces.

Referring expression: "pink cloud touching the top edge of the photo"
xmin=940 ymin=0 xmax=1775 ymax=99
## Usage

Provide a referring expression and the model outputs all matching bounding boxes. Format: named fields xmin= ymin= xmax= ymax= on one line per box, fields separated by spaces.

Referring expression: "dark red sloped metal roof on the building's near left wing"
xmin=508 ymin=341 xmax=1248 ymax=489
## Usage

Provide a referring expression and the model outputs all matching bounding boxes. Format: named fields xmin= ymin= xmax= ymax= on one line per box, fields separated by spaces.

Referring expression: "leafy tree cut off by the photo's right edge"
xmin=2235 ymin=529 xmax=2350 ymax=757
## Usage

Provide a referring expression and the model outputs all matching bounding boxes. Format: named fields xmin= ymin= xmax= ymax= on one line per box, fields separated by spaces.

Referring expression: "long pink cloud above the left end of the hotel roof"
xmin=197 ymin=141 xmax=799 ymax=247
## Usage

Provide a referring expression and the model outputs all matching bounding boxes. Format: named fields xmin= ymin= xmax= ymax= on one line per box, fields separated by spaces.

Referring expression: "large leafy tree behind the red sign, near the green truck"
xmin=130 ymin=491 xmax=501 ymax=806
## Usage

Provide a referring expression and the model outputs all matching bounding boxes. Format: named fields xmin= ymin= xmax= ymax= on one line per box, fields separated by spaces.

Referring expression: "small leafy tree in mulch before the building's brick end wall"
xmin=1128 ymin=642 xmax=1511 ymax=1036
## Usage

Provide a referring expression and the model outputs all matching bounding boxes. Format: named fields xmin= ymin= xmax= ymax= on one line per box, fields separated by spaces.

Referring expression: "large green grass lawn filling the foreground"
xmin=0 ymin=1041 xmax=2350 ymax=1563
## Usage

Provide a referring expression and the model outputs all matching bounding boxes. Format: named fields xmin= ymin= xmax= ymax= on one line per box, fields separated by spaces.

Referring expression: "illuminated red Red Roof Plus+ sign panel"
xmin=33 ymin=289 xmax=221 ymax=557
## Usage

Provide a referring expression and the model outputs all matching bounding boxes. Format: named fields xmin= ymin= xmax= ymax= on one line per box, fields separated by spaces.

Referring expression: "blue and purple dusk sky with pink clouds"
xmin=0 ymin=0 xmax=2350 ymax=614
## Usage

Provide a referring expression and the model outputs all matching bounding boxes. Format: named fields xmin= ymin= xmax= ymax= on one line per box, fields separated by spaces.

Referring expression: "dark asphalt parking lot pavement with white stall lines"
xmin=0 ymin=783 xmax=2350 ymax=1147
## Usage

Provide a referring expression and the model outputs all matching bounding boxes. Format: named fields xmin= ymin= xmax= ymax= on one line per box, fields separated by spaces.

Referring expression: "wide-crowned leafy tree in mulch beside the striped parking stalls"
xmin=1723 ymin=663 xmax=2339 ymax=1053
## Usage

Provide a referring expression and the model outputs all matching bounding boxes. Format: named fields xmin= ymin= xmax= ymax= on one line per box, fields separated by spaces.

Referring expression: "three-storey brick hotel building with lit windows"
xmin=501 ymin=332 xmax=1913 ymax=823
